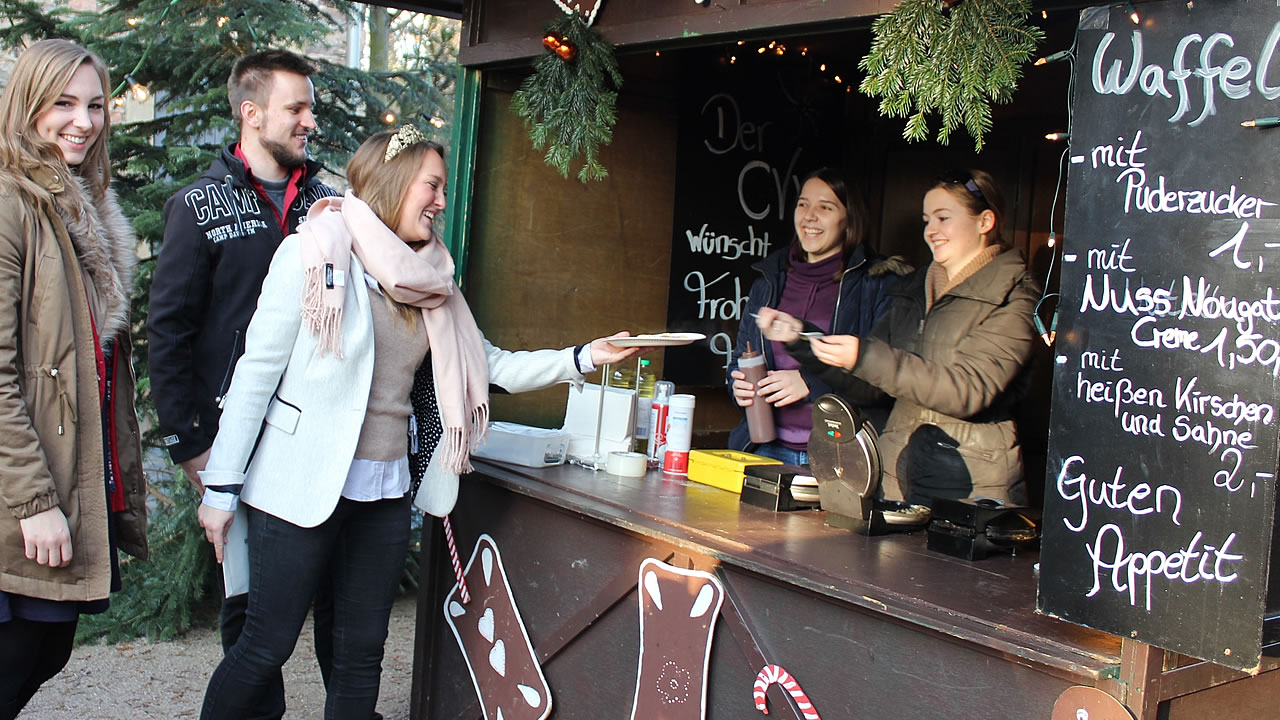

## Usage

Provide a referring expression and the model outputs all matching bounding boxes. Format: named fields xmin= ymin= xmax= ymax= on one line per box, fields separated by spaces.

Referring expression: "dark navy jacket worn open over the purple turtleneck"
xmin=724 ymin=245 xmax=910 ymax=450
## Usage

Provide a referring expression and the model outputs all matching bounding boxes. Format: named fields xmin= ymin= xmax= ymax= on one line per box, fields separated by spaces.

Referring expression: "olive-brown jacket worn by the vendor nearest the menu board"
xmin=787 ymin=250 xmax=1039 ymax=505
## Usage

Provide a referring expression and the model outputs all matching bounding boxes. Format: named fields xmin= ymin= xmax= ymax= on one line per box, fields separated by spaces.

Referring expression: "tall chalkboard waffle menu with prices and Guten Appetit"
xmin=1038 ymin=0 xmax=1280 ymax=671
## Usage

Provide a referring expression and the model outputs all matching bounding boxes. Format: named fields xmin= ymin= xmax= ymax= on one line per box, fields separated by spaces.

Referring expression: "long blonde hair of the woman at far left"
xmin=0 ymin=40 xmax=111 ymax=200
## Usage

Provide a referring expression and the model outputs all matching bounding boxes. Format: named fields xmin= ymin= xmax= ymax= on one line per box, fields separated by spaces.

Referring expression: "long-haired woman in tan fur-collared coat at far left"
xmin=0 ymin=40 xmax=146 ymax=720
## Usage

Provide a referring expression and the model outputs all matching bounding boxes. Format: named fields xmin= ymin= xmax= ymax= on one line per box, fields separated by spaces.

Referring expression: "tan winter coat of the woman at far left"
xmin=0 ymin=168 xmax=147 ymax=601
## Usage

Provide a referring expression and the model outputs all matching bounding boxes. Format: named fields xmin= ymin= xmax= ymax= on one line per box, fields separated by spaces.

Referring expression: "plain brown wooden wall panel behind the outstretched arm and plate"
xmin=465 ymin=78 xmax=676 ymax=427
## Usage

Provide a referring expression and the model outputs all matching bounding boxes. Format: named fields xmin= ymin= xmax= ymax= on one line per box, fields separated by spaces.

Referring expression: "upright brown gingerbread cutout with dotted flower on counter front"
xmin=631 ymin=557 xmax=724 ymax=720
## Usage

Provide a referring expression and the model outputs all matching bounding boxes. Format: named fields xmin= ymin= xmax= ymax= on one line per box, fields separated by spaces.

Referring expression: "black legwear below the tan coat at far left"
xmin=0 ymin=609 xmax=77 ymax=720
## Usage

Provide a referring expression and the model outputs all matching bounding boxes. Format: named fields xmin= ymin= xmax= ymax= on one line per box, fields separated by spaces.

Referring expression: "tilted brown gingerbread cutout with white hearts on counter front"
xmin=444 ymin=534 xmax=552 ymax=720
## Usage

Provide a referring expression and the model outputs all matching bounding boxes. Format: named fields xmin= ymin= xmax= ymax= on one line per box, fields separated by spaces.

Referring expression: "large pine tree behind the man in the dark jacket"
xmin=0 ymin=0 xmax=456 ymax=642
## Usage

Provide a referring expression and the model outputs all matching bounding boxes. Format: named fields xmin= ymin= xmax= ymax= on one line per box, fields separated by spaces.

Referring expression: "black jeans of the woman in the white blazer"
xmin=200 ymin=497 xmax=410 ymax=720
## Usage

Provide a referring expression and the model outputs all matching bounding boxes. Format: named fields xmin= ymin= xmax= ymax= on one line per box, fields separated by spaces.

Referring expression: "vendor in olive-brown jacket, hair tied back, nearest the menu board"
xmin=756 ymin=170 xmax=1039 ymax=505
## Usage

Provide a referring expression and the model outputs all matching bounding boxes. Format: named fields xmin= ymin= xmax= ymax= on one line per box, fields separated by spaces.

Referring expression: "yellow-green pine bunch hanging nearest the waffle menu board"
xmin=858 ymin=0 xmax=1044 ymax=151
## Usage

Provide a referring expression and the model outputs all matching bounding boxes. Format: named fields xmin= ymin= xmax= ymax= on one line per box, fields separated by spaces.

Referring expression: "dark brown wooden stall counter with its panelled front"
xmin=413 ymin=461 xmax=1280 ymax=720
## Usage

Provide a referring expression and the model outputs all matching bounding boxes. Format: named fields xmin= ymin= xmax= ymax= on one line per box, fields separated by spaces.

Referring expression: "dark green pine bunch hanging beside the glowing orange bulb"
xmin=511 ymin=13 xmax=622 ymax=183
